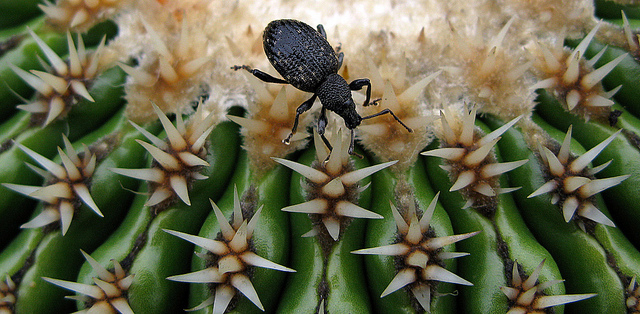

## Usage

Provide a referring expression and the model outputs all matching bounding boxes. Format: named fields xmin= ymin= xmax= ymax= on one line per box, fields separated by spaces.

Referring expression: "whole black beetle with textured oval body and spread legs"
xmin=232 ymin=19 xmax=412 ymax=154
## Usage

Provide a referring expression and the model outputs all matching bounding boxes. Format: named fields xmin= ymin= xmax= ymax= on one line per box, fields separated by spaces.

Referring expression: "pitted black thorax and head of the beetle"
xmin=316 ymin=74 xmax=362 ymax=129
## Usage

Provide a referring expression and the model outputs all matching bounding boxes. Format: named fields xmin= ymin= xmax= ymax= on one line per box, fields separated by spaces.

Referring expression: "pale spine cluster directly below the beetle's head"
xmin=273 ymin=130 xmax=397 ymax=241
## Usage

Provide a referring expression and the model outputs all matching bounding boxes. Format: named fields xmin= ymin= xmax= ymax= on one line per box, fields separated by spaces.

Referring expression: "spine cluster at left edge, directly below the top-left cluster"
xmin=2 ymin=135 xmax=103 ymax=235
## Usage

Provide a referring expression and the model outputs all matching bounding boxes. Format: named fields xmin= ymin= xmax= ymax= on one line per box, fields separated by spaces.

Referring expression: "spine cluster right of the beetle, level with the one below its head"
xmin=422 ymin=106 xmax=527 ymax=214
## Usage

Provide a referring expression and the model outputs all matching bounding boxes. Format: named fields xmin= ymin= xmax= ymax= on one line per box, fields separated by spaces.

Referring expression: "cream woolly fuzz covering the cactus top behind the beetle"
xmin=99 ymin=0 xmax=616 ymax=157
